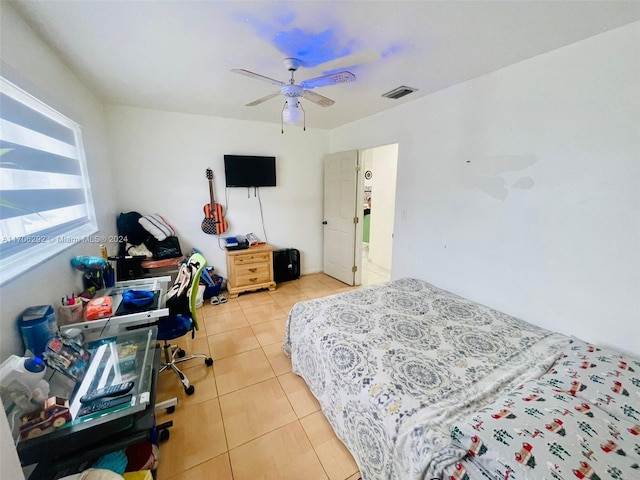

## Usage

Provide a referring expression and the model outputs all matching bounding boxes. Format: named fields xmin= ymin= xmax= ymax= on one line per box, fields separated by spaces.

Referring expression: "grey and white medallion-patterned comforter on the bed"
xmin=284 ymin=278 xmax=569 ymax=480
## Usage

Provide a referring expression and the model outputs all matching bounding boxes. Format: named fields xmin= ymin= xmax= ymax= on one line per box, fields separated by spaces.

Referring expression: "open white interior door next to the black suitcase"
xmin=323 ymin=150 xmax=359 ymax=285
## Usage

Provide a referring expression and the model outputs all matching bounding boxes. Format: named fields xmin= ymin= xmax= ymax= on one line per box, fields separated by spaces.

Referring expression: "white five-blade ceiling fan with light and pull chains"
xmin=232 ymin=58 xmax=356 ymax=133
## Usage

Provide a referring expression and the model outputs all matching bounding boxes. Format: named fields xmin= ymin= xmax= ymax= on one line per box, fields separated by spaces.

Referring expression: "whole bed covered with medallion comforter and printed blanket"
xmin=284 ymin=278 xmax=640 ymax=480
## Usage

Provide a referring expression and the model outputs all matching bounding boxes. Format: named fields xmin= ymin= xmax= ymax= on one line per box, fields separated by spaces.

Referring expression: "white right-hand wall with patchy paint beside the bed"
xmin=331 ymin=22 xmax=640 ymax=354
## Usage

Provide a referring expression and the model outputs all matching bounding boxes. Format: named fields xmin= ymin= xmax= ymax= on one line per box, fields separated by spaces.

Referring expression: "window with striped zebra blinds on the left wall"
xmin=0 ymin=77 xmax=97 ymax=285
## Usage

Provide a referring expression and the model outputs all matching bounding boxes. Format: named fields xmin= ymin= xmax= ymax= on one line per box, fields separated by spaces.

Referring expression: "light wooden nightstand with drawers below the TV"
xmin=227 ymin=244 xmax=276 ymax=298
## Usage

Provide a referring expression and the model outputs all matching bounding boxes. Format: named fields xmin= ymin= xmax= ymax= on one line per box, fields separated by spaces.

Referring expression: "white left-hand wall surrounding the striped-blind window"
xmin=0 ymin=2 xmax=115 ymax=479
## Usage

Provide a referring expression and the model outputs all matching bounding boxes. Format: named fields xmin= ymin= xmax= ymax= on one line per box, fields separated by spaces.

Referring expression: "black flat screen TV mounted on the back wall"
xmin=224 ymin=155 xmax=276 ymax=187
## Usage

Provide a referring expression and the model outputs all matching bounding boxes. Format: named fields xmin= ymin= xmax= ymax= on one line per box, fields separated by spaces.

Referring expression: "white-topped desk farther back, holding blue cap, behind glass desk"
xmin=60 ymin=276 xmax=171 ymax=341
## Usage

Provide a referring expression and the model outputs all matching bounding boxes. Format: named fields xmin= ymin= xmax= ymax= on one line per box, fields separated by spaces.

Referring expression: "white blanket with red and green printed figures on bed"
xmin=445 ymin=339 xmax=640 ymax=480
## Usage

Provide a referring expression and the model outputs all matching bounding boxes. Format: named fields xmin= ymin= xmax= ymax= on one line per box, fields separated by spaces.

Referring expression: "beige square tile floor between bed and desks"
xmin=157 ymin=274 xmax=359 ymax=480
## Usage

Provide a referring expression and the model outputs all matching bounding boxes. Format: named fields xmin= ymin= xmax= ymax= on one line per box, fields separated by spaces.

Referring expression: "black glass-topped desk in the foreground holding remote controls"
xmin=16 ymin=327 xmax=161 ymax=480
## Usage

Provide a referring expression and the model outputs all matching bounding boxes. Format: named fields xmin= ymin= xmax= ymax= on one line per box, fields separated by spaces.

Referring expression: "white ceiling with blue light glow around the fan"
xmin=8 ymin=0 xmax=640 ymax=128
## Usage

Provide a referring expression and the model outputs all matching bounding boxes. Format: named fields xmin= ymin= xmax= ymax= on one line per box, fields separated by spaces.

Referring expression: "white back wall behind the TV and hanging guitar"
xmin=107 ymin=107 xmax=329 ymax=277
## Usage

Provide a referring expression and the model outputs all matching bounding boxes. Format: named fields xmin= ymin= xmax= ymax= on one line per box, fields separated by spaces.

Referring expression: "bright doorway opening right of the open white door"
xmin=356 ymin=143 xmax=398 ymax=285
